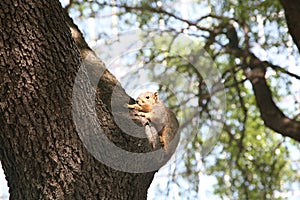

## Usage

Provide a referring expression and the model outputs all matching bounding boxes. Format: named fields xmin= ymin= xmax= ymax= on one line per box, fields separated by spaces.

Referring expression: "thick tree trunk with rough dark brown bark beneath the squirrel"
xmin=0 ymin=0 xmax=163 ymax=200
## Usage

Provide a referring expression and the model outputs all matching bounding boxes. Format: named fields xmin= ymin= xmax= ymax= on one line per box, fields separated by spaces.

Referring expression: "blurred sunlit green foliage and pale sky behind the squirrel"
xmin=62 ymin=0 xmax=300 ymax=200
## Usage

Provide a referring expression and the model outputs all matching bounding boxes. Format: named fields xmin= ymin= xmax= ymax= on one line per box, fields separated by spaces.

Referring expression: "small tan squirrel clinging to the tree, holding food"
xmin=127 ymin=92 xmax=179 ymax=152
